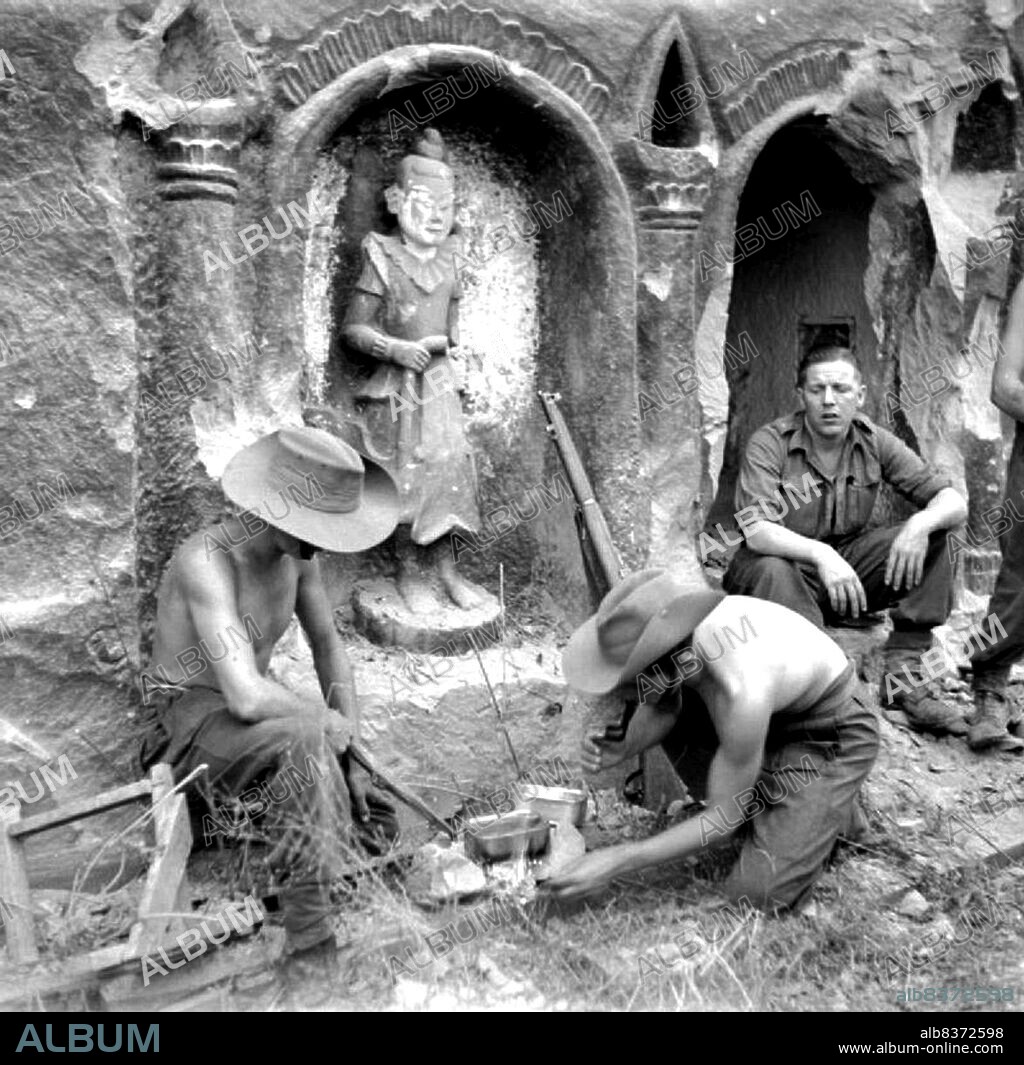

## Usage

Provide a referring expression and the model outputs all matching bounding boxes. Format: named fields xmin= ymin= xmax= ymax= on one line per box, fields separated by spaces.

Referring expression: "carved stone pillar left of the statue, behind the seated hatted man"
xmin=136 ymin=100 xmax=243 ymax=644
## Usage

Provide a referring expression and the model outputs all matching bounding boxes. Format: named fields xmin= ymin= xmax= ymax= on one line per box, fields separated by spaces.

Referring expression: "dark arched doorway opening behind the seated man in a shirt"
xmin=705 ymin=119 xmax=877 ymax=568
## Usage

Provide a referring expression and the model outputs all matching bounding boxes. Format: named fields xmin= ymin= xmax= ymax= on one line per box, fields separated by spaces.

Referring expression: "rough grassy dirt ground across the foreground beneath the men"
xmin=0 ymin=609 xmax=1024 ymax=1012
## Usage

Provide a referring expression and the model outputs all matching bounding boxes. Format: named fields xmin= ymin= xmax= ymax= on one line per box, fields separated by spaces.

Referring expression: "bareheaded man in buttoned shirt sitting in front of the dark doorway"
xmin=724 ymin=344 xmax=968 ymax=735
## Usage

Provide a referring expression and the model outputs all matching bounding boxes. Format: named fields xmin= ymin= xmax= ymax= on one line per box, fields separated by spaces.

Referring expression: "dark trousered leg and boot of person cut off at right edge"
xmin=968 ymin=422 xmax=1024 ymax=750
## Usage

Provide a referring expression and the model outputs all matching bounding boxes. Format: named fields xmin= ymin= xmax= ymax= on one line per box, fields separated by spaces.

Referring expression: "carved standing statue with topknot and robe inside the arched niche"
xmin=342 ymin=129 xmax=495 ymax=629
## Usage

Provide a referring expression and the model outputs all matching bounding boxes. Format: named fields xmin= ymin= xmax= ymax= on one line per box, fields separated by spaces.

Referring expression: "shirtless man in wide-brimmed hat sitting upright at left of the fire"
xmin=142 ymin=428 xmax=398 ymax=966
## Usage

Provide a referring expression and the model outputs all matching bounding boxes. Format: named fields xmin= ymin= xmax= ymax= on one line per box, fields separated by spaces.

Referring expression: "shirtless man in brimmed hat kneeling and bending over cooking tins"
xmin=547 ymin=570 xmax=878 ymax=912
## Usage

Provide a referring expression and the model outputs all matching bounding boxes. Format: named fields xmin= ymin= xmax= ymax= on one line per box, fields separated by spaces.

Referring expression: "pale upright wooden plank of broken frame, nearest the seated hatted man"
xmin=128 ymin=763 xmax=192 ymax=957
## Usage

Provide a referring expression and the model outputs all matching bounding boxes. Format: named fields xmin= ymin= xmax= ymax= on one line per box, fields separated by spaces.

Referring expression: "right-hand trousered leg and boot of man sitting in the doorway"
xmin=836 ymin=526 xmax=968 ymax=736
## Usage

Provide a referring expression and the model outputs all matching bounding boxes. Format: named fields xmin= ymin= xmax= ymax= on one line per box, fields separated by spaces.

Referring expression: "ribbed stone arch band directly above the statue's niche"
xmin=279 ymin=3 xmax=611 ymax=119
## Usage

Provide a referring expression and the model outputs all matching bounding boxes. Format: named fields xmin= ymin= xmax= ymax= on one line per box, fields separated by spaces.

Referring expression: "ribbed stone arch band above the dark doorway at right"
xmin=723 ymin=43 xmax=859 ymax=141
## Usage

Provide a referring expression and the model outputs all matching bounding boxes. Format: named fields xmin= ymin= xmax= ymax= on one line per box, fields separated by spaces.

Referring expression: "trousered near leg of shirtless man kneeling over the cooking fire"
xmin=724 ymin=666 xmax=878 ymax=912
